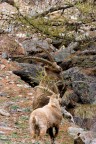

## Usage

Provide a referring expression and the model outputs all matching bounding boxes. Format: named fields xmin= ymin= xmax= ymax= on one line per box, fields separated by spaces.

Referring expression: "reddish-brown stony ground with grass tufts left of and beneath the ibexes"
xmin=0 ymin=55 xmax=73 ymax=144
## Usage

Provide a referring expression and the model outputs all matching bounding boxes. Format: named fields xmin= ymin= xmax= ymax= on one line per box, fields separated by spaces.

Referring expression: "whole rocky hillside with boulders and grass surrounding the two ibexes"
xmin=0 ymin=0 xmax=96 ymax=144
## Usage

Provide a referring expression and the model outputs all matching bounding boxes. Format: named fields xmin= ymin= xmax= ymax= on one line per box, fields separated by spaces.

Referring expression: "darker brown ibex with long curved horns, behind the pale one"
xmin=30 ymin=46 xmax=62 ymax=110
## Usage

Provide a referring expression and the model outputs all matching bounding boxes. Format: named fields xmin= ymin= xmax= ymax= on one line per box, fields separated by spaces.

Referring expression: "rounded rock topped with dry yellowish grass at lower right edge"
xmin=73 ymin=104 xmax=96 ymax=132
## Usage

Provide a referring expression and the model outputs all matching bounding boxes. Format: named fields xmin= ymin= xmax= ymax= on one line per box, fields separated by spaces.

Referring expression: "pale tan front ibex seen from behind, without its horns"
xmin=29 ymin=94 xmax=62 ymax=144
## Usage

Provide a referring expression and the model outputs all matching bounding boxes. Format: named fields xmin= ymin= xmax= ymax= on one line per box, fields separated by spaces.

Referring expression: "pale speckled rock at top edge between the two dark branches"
xmin=12 ymin=0 xmax=62 ymax=17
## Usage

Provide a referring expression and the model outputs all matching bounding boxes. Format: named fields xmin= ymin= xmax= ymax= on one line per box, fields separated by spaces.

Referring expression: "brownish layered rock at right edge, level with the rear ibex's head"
xmin=60 ymin=54 xmax=96 ymax=70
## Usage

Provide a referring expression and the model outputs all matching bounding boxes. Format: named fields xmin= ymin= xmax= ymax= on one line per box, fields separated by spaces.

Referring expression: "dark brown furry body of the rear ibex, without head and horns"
xmin=33 ymin=69 xmax=60 ymax=110
